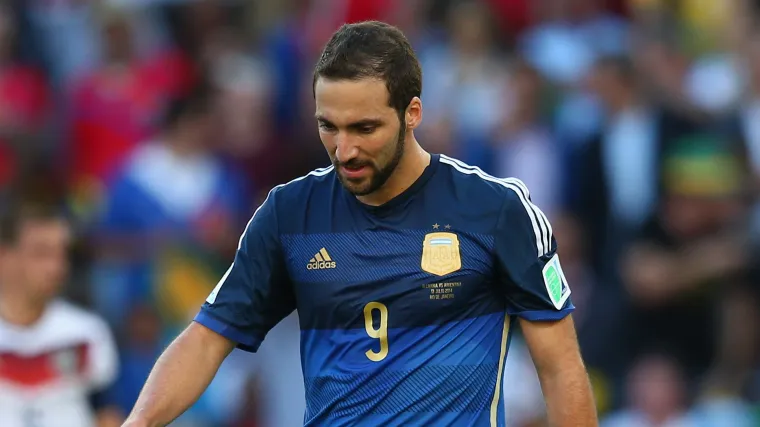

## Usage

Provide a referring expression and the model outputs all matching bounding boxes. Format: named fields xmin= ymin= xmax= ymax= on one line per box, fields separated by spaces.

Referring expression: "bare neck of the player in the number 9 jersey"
xmin=357 ymin=138 xmax=431 ymax=206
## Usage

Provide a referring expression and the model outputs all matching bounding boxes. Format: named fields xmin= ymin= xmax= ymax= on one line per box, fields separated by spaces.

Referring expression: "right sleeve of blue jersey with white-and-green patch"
xmin=495 ymin=179 xmax=574 ymax=321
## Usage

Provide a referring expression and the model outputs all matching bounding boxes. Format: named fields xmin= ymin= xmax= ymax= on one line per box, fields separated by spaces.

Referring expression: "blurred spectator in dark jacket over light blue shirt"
xmin=573 ymin=57 xmax=698 ymax=274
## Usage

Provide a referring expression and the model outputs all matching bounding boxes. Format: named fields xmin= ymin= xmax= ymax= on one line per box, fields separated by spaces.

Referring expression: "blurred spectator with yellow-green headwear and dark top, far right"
xmin=622 ymin=136 xmax=749 ymax=381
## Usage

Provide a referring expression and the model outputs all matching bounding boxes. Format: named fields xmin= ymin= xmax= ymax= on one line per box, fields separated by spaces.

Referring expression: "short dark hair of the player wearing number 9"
xmin=312 ymin=21 xmax=422 ymax=114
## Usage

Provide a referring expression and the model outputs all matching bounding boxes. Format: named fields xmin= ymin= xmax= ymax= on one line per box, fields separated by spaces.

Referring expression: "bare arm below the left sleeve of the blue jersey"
xmin=125 ymin=323 xmax=233 ymax=427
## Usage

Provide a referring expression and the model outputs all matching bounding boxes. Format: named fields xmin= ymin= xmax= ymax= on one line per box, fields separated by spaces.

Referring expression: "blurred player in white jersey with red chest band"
xmin=0 ymin=206 xmax=120 ymax=427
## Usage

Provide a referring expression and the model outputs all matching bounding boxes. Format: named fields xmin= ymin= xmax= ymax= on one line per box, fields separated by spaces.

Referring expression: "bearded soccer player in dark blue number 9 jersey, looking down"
xmin=127 ymin=22 xmax=597 ymax=427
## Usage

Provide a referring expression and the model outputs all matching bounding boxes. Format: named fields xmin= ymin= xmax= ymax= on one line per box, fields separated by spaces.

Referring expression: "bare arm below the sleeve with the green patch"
xmin=520 ymin=316 xmax=598 ymax=427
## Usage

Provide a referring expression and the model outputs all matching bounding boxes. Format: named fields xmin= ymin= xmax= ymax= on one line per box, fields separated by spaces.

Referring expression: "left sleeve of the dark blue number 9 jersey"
xmin=195 ymin=189 xmax=295 ymax=351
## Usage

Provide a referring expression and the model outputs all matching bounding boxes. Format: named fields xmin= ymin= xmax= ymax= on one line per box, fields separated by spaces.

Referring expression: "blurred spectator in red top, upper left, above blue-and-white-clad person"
xmin=66 ymin=6 xmax=194 ymax=221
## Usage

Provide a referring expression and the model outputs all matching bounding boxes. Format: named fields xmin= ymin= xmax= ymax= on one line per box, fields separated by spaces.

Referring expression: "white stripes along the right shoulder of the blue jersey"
xmin=440 ymin=154 xmax=552 ymax=256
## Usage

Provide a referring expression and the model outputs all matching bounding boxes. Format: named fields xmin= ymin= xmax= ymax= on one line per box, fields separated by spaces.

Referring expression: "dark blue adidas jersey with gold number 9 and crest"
xmin=195 ymin=155 xmax=573 ymax=426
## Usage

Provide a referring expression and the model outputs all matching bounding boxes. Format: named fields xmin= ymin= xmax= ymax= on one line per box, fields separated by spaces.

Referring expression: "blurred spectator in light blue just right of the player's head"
xmin=420 ymin=1 xmax=507 ymax=169
